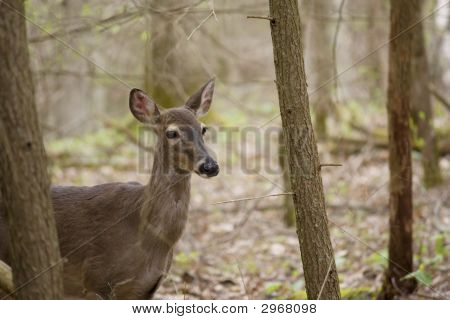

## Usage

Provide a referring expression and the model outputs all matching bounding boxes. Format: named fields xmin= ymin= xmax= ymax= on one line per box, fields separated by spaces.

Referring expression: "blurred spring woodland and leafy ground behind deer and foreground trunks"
xmin=19 ymin=0 xmax=450 ymax=299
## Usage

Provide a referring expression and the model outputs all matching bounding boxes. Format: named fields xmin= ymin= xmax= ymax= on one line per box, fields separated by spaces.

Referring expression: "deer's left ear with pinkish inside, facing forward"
xmin=130 ymin=89 xmax=160 ymax=123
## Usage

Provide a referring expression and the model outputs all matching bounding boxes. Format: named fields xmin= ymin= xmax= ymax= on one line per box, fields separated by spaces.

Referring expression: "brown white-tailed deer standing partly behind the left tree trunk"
xmin=0 ymin=80 xmax=219 ymax=299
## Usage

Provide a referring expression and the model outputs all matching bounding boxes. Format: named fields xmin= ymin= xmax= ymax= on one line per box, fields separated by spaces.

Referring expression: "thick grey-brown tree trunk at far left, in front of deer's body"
xmin=0 ymin=0 xmax=63 ymax=299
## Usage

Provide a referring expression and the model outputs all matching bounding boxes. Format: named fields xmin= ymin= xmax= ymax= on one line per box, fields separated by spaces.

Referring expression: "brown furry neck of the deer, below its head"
xmin=139 ymin=145 xmax=191 ymax=250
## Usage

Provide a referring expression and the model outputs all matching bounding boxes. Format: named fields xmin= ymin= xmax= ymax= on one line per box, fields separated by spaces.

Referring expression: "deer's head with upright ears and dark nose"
xmin=130 ymin=79 xmax=219 ymax=178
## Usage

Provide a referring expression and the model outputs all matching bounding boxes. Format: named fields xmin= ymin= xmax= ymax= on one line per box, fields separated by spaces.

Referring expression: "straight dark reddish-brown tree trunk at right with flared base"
xmin=378 ymin=0 xmax=420 ymax=299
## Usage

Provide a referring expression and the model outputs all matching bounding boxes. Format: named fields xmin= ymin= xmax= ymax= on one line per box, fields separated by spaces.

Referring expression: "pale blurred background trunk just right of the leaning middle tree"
xmin=307 ymin=0 xmax=335 ymax=138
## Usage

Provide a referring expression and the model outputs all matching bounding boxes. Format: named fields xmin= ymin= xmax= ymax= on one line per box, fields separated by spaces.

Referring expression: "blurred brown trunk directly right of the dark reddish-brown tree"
xmin=411 ymin=1 xmax=442 ymax=187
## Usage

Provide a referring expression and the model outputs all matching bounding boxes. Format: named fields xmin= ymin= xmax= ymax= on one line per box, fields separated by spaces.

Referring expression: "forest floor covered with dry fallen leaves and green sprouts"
xmin=50 ymin=132 xmax=450 ymax=299
